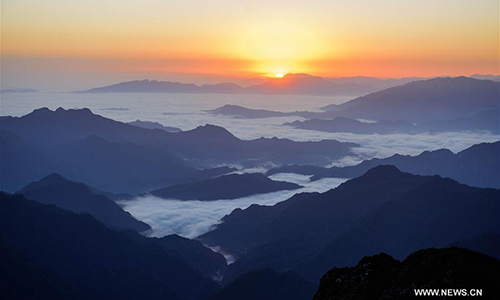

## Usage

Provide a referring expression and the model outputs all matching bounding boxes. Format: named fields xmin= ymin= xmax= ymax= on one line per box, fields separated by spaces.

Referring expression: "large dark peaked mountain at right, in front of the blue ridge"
xmin=198 ymin=166 xmax=500 ymax=282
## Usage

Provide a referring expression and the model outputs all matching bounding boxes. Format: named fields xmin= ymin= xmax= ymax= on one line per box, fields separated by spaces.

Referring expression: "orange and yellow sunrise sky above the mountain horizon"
xmin=1 ymin=0 xmax=500 ymax=90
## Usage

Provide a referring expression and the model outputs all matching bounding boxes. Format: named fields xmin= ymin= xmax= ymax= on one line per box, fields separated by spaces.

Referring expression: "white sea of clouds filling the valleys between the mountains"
xmin=4 ymin=92 xmax=500 ymax=238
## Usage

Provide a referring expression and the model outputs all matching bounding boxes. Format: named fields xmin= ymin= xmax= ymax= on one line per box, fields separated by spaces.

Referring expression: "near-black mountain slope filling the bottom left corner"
xmin=0 ymin=193 xmax=219 ymax=300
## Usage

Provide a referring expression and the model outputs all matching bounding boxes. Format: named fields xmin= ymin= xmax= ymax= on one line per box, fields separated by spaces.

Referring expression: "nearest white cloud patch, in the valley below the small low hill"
xmin=120 ymin=174 xmax=346 ymax=238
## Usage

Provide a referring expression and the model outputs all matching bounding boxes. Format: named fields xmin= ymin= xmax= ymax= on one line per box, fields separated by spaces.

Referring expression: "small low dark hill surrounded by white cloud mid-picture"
xmin=151 ymin=173 xmax=301 ymax=201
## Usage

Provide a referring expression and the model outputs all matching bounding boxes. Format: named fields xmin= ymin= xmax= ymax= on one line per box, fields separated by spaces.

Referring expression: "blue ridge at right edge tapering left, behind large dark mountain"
xmin=266 ymin=141 xmax=500 ymax=188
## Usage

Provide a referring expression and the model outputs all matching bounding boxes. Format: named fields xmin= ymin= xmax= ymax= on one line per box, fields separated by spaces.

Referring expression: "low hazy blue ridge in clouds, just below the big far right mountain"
xmin=283 ymin=117 xmax=418 ymax=134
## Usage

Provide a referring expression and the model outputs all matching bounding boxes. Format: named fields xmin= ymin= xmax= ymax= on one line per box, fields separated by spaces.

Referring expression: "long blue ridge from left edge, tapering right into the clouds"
xmin=0 ymin=108 xmax=358 ymax=193
